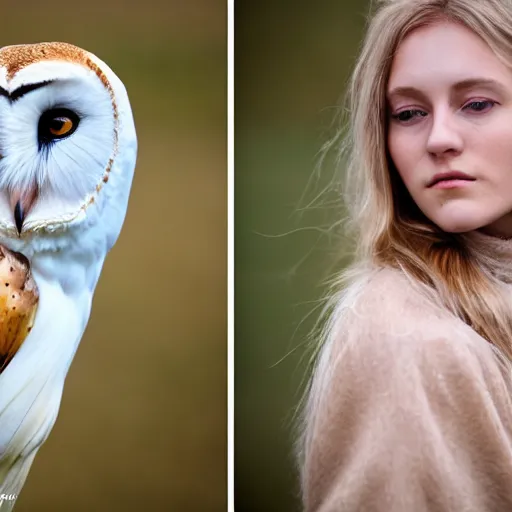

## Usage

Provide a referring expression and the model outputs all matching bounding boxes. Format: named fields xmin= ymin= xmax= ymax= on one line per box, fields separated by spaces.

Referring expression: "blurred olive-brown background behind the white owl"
xmin=0 ymin=0 xmax=227 ymax=512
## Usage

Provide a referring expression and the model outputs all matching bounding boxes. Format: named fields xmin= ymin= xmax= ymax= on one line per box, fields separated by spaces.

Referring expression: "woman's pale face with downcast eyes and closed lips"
xmin=387 ymin=22 xmax=512 ymax=236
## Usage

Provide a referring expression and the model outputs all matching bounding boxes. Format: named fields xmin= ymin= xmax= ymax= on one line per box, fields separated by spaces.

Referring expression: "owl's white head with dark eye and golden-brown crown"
xmin=0 ymin=43 xmax=137 ymax=254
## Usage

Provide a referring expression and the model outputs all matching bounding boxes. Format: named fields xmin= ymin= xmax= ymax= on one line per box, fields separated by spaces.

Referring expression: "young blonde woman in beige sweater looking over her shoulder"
xmin=300 ymin=0 xmax=512 ymax=512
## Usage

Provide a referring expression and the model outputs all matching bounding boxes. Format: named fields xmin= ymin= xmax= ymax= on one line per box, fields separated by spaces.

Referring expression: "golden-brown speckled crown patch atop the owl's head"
xmin=0 ymin=43 xmax=92 ymax=80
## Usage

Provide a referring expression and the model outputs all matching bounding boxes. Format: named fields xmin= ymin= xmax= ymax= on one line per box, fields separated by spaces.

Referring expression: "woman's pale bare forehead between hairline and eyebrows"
xmin=388 ymin=22 xmax=512 ymax=90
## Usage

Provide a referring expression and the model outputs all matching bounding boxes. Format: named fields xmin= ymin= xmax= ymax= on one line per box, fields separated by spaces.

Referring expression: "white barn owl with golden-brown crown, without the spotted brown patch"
xmin=0 ymin=43 xmax=137 ymax=512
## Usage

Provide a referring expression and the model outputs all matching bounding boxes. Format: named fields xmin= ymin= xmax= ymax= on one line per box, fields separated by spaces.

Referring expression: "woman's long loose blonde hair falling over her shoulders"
xmin=299 ymin=0 xmax=512 ymax=492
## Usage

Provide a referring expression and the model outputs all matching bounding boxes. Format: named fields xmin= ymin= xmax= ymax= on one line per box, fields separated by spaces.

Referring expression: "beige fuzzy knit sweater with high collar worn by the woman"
xmin=302 ymin=232 xmax=512 ymax=512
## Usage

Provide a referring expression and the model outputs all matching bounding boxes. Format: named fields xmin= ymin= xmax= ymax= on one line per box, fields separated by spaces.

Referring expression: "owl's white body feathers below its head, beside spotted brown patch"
xmin=0 ymin=241 xmax=104 ymax=500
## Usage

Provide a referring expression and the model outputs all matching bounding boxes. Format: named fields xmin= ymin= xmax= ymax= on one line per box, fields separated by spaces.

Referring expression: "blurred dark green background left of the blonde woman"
xmin=235 ymin=0 xmax=368 ymax=512
